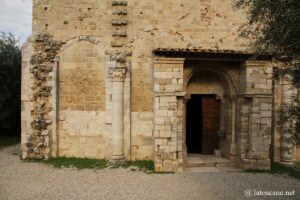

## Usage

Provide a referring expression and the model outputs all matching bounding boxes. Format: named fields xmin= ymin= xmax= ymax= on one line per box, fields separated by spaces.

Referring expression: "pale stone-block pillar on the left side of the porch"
xmin=154 ymin=58 xmax=184 ymax=171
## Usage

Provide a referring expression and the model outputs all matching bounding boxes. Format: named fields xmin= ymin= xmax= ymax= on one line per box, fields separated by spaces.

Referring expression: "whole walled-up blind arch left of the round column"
xmin=56 ymin=36 xmax=107 ymax=159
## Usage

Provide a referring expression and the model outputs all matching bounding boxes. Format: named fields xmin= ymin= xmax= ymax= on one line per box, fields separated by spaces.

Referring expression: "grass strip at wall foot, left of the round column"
xmin=26 ymin=158 xmax=108 ymax=169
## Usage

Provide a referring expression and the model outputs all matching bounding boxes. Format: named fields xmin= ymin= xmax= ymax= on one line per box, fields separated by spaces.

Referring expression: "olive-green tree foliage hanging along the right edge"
xmin=234 ymin=0 xmax=300 ymax=144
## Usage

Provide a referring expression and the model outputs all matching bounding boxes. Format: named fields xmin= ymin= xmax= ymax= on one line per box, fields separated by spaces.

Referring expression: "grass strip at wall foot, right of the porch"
xmin=246 ymin=163 xmax=300 ymax=181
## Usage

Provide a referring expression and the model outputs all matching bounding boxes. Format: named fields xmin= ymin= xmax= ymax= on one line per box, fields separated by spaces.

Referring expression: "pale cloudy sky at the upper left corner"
xmin=0 ymin=0 xmax=32 ymax=44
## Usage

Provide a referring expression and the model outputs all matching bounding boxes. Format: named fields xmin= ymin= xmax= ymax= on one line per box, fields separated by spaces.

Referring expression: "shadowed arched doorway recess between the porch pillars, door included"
xmin=184 ymin=62 xmax=238 ymax=157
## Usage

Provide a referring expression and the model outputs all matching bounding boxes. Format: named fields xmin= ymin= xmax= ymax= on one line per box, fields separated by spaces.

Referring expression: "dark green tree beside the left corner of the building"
xmin=0 ymin=32 xmax=21 ymax=135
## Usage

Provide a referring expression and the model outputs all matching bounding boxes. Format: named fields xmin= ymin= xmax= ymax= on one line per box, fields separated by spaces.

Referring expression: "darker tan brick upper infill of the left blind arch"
xmin=59 ymin=41 xmax=105 ymax=111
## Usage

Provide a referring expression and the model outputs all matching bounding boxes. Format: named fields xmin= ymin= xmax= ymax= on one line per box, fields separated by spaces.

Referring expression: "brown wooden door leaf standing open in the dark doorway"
xmin=202 ymin=96 xmax=219 ymax=154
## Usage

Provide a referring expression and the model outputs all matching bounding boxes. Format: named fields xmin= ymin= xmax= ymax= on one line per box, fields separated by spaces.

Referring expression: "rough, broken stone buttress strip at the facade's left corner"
xmin=21 ymin=34 xmax=61 ymax=158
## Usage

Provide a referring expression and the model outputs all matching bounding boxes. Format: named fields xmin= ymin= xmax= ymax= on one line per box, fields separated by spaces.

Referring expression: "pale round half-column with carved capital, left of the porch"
xmin=110 ymin=67 xmax=126 ymax=163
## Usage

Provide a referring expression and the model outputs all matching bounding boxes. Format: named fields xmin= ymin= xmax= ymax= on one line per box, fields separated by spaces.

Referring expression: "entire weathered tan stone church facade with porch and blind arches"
xmin=22 ymin=0 xmax=300 ymax=171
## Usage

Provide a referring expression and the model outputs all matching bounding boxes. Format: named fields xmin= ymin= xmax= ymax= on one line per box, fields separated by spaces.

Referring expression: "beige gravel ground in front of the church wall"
xmin=0 ymin=146 xmax=300 ymax=200
